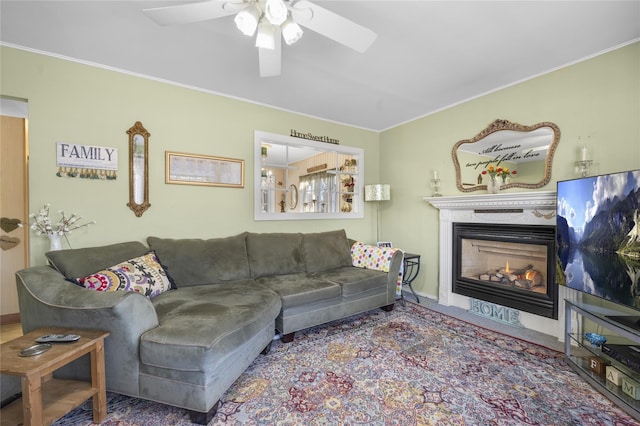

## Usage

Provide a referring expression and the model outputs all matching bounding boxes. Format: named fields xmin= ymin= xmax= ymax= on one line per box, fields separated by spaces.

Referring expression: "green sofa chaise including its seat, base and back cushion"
xmin=148 ymin=234 xmax=281 ymax=422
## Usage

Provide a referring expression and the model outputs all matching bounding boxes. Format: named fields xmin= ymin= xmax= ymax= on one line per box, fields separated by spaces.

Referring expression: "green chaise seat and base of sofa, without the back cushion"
xmin=140 ymin=280 xmax=280 ymax=422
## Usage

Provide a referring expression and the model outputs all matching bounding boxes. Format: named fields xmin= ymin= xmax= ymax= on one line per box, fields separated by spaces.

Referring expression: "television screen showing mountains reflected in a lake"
xmin=556 ymin=170 xmax=640 ymax=310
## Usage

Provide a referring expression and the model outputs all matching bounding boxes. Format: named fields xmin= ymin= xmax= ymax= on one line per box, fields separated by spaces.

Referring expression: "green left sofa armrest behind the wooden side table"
xmin=16 ymin=266 xmax=158 ymax=396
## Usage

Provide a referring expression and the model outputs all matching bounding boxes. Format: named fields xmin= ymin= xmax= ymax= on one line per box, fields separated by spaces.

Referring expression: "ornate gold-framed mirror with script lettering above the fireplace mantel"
xmin=451 ymin=120 xmax=560 ymax=192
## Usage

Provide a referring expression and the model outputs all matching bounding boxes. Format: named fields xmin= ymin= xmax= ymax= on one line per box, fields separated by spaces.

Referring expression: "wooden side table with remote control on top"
xmin=0 ymin=327 xmax=109 ymax=426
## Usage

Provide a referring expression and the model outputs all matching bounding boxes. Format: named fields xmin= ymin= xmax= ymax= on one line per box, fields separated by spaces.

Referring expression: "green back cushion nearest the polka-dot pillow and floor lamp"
xmin=302 ymin=229 xmax=352 ymax=272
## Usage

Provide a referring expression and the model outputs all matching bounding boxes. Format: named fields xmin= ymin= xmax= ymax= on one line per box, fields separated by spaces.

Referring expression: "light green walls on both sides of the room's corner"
xmin=0 ymin=43 xmax=640 ymax=297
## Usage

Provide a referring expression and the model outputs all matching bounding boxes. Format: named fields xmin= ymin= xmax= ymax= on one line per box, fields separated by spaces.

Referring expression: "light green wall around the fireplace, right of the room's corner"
xmin=380 ymin=43 xmax=640 ymax=297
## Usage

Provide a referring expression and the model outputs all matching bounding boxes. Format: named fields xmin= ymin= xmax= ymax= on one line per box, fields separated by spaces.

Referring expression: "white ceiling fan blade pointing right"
xmin=292 ymin=0 xmax=378 ymax=53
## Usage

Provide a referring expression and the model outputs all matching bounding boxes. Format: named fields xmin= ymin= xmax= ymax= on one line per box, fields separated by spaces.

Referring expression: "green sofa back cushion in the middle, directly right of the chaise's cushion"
xmin=247 ymin=233 xmax=305 ymax=278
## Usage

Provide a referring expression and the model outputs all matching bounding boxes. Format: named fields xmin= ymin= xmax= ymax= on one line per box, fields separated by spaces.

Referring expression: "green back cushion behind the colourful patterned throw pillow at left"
xmin=45 ymin=241 xmax=149 ymax=280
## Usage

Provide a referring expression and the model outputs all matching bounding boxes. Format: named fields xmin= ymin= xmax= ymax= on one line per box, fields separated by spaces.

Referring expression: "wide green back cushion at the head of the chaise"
xmin=147 ymin=233 xmax=250 ymax=288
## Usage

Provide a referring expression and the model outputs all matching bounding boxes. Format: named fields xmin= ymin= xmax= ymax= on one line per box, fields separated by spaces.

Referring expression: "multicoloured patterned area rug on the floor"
xmin=55 ymin=303 xmax=638 ymax=426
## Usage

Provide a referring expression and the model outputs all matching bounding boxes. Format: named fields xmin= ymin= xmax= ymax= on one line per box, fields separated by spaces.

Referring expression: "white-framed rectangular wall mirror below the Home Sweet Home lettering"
xmin=254 ymin=131 xmax=364 ymax=220
